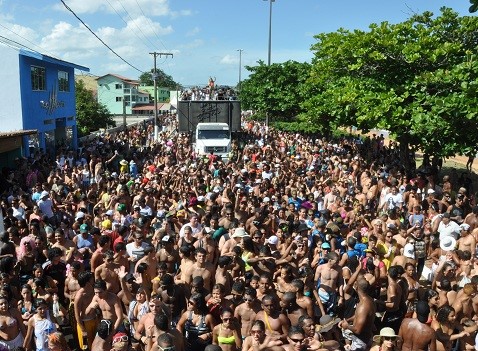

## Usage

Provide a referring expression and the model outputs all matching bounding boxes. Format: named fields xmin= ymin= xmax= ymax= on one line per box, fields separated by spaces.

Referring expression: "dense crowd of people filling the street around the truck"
xmin=0 ymin=113 xmax=478 ymax=351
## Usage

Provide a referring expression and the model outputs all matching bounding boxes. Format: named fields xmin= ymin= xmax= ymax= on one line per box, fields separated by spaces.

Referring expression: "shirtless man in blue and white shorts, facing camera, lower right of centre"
xmin=314 ymin=252 xmax=343 ymax=313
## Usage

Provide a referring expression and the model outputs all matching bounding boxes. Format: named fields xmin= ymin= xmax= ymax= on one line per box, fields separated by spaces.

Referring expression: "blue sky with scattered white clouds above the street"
xmin=0 ymin=0 xmax=469 ymax=85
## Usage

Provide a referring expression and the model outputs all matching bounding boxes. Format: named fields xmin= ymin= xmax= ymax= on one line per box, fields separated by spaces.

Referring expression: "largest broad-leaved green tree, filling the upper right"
xmin=302 ymin=8 xmax=478 ymax=166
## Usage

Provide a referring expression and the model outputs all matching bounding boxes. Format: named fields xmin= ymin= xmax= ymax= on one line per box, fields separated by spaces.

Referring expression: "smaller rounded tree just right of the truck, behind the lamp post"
xmin=240 ymin=61 xmax=310 ymax=120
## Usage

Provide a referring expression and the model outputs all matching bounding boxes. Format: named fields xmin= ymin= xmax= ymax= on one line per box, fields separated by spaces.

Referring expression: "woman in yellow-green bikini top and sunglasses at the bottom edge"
xmin=212 ymin=307 xmax=242 ymax=351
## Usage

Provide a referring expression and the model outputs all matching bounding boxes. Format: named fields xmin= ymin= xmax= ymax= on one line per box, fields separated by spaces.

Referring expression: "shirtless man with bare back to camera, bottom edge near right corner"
xmin=398 ymin=301 xmax=436 ymax=351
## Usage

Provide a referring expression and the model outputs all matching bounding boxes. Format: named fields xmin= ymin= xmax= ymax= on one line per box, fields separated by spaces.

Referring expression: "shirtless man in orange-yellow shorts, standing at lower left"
xmin=73 ymin=272 xmax=97 ymax=350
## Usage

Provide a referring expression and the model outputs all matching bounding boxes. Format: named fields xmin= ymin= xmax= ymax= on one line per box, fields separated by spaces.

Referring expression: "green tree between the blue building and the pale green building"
xmin=75 ymin=79 xmax=116 ymax=135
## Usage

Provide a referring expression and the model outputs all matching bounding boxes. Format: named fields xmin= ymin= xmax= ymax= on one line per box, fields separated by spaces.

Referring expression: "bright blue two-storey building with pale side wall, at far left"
xmin=0 ymin=43 xmax=89 ymax=163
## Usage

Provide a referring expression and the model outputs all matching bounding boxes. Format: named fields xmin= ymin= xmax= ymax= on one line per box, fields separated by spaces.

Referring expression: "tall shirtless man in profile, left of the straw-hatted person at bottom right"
xmin=339 ymin=276 xmax=375 ymax=351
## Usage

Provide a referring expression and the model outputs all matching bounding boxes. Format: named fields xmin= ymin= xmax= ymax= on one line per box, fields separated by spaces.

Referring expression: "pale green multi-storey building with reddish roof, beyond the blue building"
xmin=96 ymin=73 xmax=150 ymax=115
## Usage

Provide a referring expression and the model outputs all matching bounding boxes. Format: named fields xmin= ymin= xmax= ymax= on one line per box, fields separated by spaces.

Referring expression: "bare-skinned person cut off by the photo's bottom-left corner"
xmin=0 ymin=296 xmax=26 ymax=350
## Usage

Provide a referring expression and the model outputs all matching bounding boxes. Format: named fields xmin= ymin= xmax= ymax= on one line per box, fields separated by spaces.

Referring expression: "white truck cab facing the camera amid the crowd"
xmin=194 ymin=122 xmax=231 ymax=160
